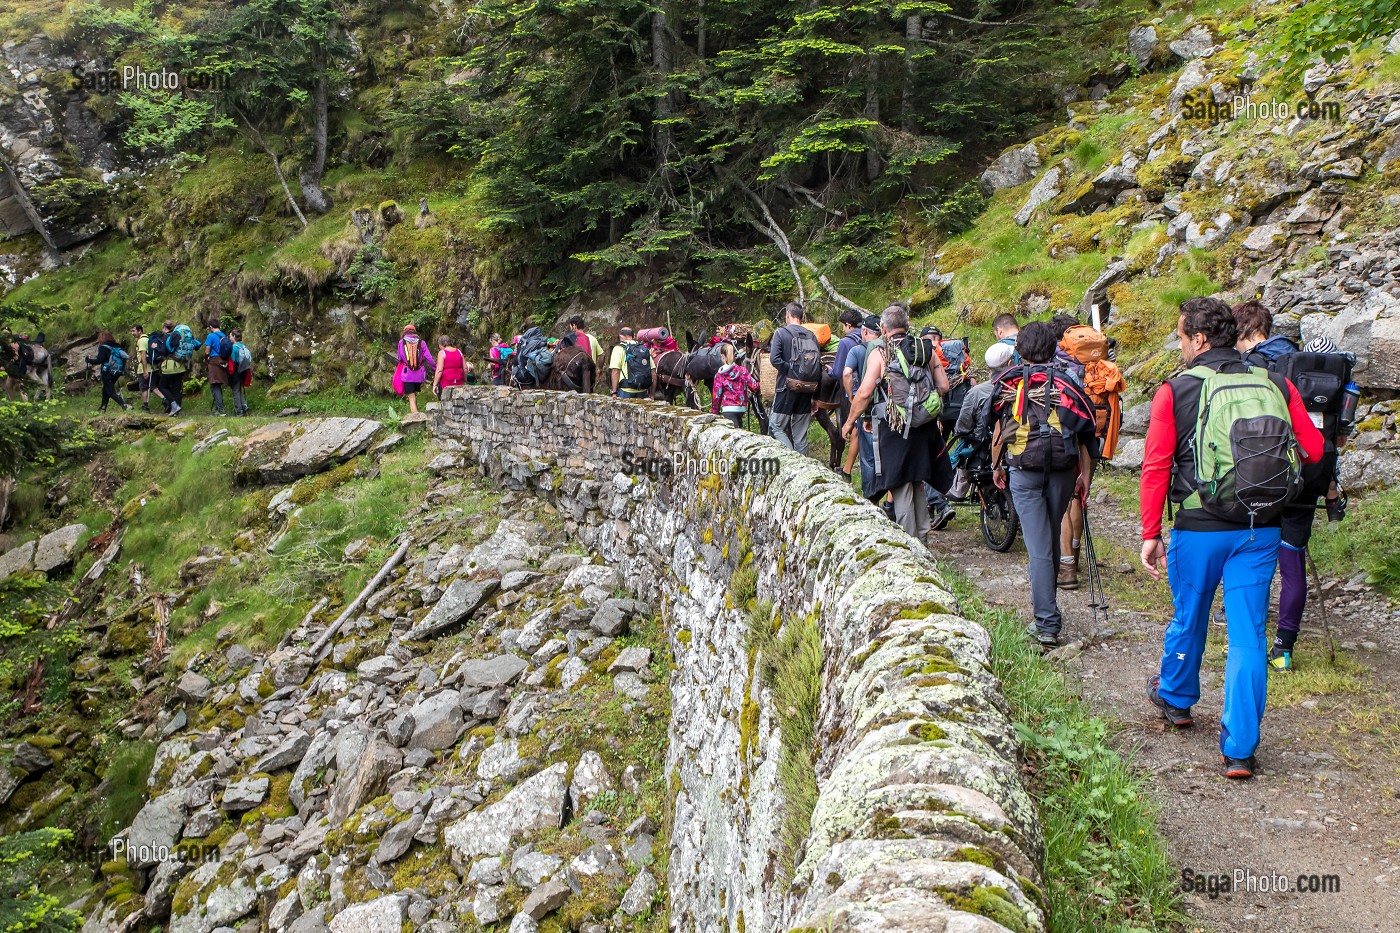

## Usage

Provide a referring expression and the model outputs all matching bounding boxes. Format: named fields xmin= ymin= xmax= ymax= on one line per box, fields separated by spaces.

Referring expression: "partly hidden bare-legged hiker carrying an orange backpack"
xmin=1050 ymin=315 xmax=1127 ymax=590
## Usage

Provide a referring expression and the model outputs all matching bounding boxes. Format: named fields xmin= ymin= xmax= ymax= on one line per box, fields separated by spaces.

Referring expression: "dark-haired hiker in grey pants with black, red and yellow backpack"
xmin=993 ymin=321 xmax=1098 ymax=649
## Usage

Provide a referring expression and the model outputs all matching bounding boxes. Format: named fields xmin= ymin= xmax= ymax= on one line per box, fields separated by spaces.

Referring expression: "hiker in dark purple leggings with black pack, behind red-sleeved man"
xmin=1233 ymin=301 xmax=1351 ymax=672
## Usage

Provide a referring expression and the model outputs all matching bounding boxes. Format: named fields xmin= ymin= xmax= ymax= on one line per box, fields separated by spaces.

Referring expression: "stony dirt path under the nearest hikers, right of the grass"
xmin=937 ymin=479 xmax=1400 ymax=933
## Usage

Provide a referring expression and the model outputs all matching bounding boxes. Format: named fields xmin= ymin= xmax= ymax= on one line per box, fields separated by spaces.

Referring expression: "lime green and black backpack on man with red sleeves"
xmin=1182 ymin=366 xmax=1302 ymax=528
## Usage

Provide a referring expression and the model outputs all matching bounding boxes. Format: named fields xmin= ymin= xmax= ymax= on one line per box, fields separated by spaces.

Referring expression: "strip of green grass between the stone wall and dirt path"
xmin=942 ymin=565 xmax=1186 ymax=933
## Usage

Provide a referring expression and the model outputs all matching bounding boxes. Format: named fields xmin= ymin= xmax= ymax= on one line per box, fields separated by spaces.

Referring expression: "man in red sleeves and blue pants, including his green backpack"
xmin=1140 ymin=298 xmax=1323 ymax=778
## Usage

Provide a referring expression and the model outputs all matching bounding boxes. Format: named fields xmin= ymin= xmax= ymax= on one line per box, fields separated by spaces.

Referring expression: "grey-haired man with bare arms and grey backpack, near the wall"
xmin=841 ymin=304 xmax=948 ymax=541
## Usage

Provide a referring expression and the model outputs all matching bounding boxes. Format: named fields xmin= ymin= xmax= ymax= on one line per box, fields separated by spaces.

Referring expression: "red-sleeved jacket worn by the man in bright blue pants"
xmin=1138 ymin=350 xmax=1324 ymax=541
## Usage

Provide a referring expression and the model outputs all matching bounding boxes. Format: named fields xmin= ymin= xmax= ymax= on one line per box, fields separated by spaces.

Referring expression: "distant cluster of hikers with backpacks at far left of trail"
xmin=84 ymin=321 xmax=253 ymax=417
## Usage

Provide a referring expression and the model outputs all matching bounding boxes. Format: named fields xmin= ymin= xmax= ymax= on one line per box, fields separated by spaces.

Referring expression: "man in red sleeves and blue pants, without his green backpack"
xmin=1140 ymin=298 xmax=1323 ymax=778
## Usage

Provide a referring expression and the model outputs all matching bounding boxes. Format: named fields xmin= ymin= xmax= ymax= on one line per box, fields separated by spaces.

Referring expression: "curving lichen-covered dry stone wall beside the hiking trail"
xmin=434 ymin=387 xmax=1044 ymax=933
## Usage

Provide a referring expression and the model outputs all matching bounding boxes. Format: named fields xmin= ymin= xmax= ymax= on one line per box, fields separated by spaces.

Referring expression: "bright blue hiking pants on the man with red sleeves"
xmin=1159 ymin=528 xmax=1280 ymax=758
